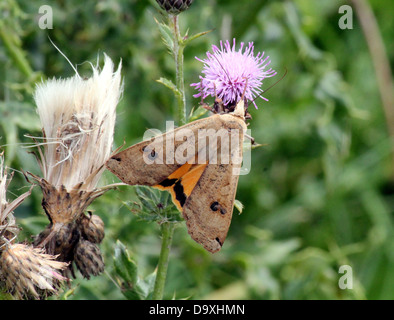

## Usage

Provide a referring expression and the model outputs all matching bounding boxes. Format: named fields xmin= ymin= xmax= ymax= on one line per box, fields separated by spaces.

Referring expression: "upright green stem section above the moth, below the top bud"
xmin=169 ymin=15 xmax=187 ymax=126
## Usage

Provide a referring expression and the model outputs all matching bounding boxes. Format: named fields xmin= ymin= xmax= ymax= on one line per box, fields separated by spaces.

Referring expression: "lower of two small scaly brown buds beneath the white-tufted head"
xmin=74 ymin=239 xmax=104 ymax=279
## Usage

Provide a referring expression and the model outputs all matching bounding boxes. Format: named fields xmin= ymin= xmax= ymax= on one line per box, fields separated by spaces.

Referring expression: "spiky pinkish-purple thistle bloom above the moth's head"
xmin=191 ymin=39 xmax=276 ymax=109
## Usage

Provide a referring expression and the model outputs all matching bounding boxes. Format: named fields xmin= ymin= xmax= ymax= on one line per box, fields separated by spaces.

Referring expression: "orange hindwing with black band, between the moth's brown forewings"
xmin=153 ymin=163 xmax=207 ymax=212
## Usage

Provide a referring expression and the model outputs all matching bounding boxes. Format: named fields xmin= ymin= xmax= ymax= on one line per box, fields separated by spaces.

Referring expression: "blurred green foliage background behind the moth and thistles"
xmin=0 ymin=0 xmax=394 ymax=299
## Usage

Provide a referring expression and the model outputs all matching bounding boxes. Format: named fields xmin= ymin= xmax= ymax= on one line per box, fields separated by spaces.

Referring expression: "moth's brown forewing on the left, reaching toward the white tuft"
xmin=106 ymin=117 xmax=220 ymax=186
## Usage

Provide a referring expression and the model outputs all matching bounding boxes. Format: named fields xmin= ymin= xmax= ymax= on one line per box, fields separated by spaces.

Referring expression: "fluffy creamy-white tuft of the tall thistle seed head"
xmin=34 ymin=55 xmax=123 ymax=190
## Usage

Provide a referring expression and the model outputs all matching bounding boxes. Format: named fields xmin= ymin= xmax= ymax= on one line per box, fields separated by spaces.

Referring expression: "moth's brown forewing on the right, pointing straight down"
xmin=183 ymin=116 xmax=246 ymax=253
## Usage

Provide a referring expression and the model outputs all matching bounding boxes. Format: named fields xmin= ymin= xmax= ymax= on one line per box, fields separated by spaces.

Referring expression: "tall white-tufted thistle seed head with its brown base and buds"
xmin=29 ymin=56 xmax=122 ymax=278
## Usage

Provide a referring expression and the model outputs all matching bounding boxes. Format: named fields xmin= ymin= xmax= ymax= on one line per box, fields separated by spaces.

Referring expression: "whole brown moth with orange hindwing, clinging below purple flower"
xmin=106 ymin=97 xmax=246 ymax=253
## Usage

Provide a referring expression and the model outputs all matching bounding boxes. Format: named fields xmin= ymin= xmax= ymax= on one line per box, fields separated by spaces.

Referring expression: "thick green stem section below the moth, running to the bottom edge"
xmin=152 ymin=222 xmax=175 ymax=300
